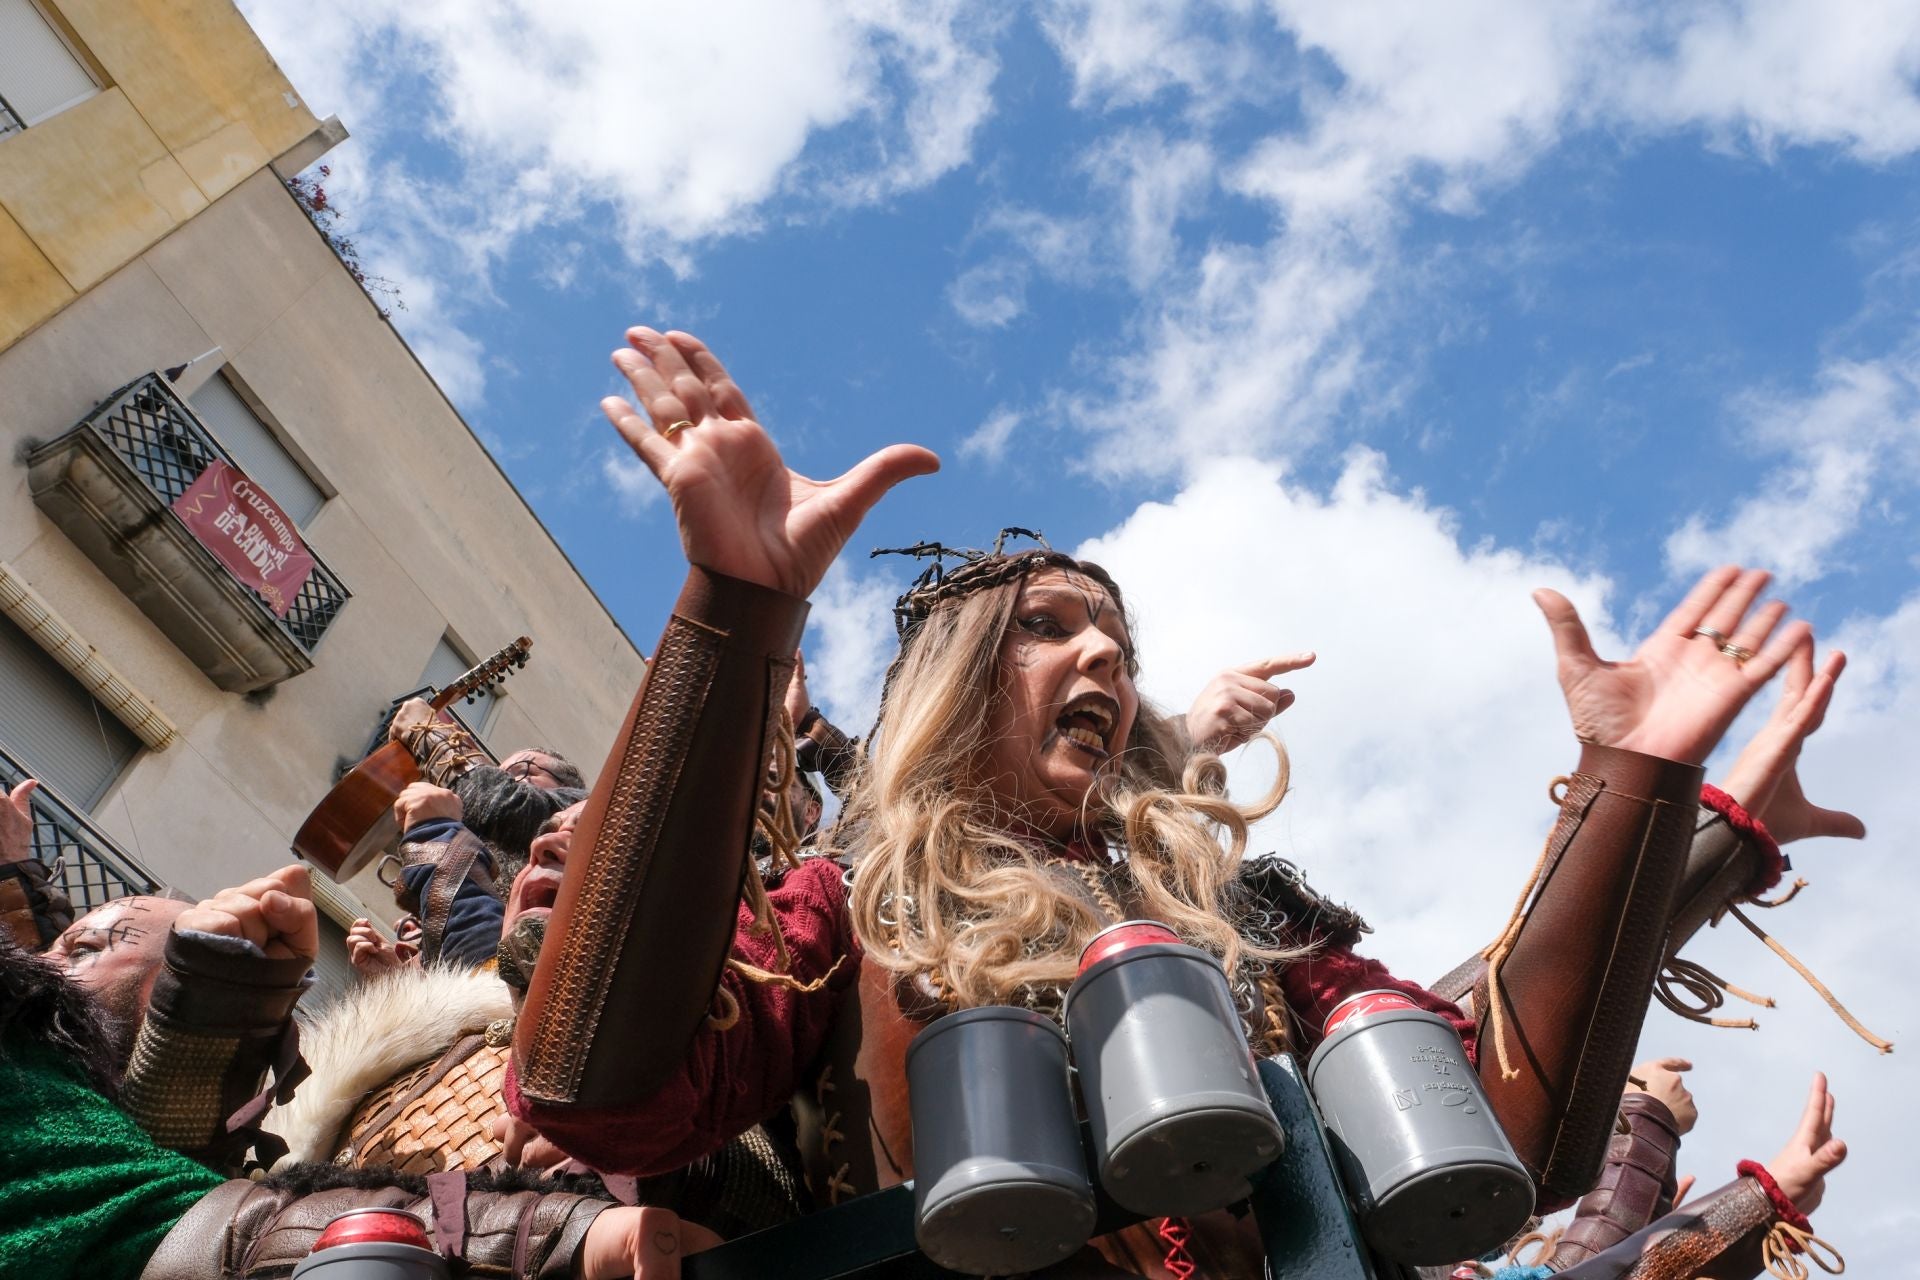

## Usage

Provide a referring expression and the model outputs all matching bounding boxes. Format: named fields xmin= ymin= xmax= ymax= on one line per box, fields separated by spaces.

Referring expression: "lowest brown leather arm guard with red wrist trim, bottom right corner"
xmin=1561 ymin=1165 xmax=1820 ymax=1280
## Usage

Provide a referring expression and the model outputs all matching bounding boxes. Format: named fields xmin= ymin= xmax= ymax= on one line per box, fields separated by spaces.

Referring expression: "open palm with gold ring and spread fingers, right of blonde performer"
xmin=1534 ymin=564 xmax=1812 ymax=764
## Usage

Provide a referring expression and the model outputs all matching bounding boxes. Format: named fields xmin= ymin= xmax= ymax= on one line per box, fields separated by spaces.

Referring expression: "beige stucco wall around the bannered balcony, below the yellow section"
xmin=0 ymin=167 xmax=643 ymax=913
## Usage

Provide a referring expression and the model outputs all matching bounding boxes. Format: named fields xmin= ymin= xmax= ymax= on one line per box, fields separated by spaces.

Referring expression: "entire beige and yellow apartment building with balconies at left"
xmin=0 ymin=0 xmax=643 ymax=973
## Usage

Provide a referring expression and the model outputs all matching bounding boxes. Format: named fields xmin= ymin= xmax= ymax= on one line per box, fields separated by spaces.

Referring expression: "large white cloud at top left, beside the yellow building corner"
xmin=244 ymin=0 xmax=998 ymax=401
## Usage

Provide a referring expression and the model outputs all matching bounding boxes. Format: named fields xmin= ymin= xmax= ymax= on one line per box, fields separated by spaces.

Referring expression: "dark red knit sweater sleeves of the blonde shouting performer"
xmin=507 ymin=858 xmax=1475 ymax=1176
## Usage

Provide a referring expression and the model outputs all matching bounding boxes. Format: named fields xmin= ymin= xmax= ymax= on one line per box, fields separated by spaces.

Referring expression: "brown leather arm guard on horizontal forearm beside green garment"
xmin=140 ymin=1174 xmax=609 ymax=1280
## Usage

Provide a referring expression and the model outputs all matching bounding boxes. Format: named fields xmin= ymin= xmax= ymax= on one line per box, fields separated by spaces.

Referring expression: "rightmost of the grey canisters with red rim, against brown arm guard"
xmin=1308 ymin=990 xmax=1534 ymax=1267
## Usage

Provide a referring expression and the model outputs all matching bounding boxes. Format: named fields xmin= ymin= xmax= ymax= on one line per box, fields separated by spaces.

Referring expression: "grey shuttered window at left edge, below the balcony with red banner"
xmin=0 ymin=616 xmax=140 ymax=810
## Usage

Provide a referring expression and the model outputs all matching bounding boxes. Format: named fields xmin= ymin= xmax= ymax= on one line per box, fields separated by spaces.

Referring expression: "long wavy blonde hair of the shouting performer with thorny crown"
xmin=835 ymin=564 xmax=1298 ymax=1007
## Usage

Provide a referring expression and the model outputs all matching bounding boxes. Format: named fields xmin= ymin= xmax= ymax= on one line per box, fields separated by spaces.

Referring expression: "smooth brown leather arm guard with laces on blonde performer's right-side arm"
xmin=1434 ymin=745 xmax=1701 ymax=1203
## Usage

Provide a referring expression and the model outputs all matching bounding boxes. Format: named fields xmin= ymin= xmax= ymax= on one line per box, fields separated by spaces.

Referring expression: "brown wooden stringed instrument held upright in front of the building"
xmin=294 ymin=635 xmax=534 ymax=881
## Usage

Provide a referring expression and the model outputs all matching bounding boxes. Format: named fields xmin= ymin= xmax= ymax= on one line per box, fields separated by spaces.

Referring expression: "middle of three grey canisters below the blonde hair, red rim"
xmin=1066 ymin=921 xmax=1284 ymax=1217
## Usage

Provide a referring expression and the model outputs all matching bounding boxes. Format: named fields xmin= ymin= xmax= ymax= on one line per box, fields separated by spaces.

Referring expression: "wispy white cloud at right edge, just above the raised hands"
xmin=1667 ymin=355 xmax=1920 ymax=583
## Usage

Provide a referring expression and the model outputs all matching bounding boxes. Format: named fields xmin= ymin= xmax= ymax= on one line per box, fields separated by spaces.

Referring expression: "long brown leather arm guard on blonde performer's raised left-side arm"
xmin=513 ymin=566 xmax=806 ymax=1107
